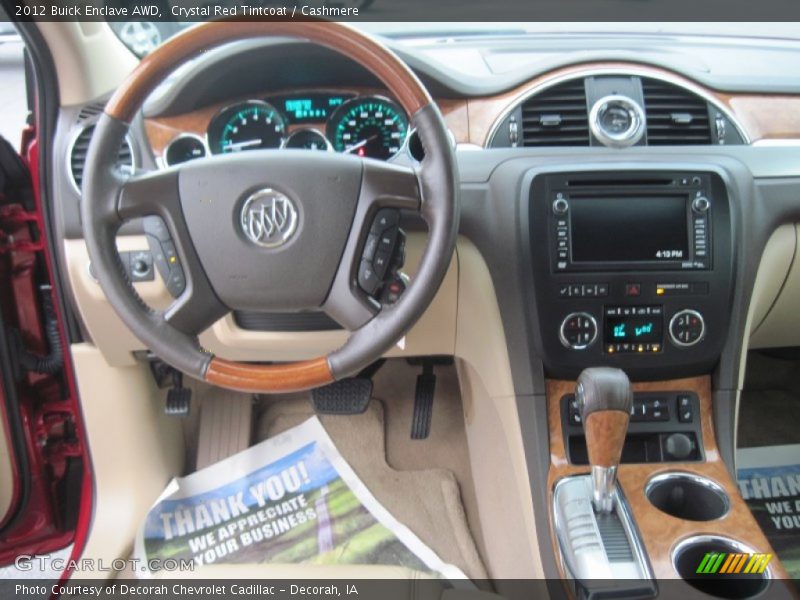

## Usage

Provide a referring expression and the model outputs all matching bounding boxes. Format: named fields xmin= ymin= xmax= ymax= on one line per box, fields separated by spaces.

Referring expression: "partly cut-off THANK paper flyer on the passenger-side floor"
xmin=737 ymin=445 xmax=800 ymax=579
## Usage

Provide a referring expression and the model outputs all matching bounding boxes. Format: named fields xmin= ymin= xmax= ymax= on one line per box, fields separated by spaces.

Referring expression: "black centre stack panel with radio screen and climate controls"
xmin=528 ymin=170 xmax=733 ymax=379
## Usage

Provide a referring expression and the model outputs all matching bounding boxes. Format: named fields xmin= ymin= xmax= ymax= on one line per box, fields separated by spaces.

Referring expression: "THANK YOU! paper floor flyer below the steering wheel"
xmin=135 ymin=417 xmax=466 ymax=580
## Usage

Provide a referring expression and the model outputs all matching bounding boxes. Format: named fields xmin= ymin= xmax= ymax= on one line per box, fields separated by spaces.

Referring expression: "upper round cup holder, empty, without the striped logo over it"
xmin=645 ymin=472 xmax=730 ymax=521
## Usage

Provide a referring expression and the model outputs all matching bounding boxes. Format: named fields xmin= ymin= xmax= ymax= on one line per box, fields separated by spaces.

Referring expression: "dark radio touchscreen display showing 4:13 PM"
xmin=570 ymin=196 xmax=690 ymax=263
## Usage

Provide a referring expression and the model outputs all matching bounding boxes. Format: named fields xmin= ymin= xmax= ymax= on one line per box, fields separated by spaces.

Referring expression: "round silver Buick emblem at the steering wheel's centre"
xmin=241 ymin=188 xmax=298 ymax=248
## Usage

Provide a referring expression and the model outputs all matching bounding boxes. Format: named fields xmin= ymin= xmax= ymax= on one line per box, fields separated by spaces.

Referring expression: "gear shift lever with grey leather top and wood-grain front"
xmin=575 ymin=367 xmax=633 ymax=513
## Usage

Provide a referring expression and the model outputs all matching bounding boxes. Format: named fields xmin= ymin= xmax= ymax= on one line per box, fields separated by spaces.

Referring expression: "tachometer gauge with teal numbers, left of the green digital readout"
xmin=208 ymin=100 xmax=286 ymax=154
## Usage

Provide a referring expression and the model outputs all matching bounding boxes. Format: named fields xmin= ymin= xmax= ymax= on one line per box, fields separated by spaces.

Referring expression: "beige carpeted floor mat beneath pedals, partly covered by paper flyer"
xmin=255 ymin=392 xmax=486 ymax=579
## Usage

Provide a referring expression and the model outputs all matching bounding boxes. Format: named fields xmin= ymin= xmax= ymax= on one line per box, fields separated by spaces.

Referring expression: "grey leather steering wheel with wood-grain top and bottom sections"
xmin=81 ymin=21 xmax=459 ymax=393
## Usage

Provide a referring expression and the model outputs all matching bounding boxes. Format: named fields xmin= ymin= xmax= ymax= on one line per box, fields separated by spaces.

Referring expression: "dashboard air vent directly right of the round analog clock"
xmin=642 ymin=77 xmax=712 ymax=146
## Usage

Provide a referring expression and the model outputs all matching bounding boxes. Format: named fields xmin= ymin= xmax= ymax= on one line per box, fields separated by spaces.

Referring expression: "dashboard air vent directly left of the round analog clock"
xmin=522 ymin=79 xmax=589 ymax=146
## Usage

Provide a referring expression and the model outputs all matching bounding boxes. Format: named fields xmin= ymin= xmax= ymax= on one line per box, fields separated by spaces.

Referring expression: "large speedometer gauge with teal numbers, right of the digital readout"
xmin=328 ymin=96 xmax=408 ymax=160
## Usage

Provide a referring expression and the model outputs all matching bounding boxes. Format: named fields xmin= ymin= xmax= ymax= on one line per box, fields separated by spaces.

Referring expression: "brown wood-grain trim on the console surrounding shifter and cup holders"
xmin=547 ymin=376 xmax=791 ymax=597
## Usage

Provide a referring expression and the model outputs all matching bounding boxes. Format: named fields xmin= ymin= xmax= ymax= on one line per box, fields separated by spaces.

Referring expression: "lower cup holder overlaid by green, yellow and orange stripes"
xmin=672 ymin=535 xmax=769 ymax=599
